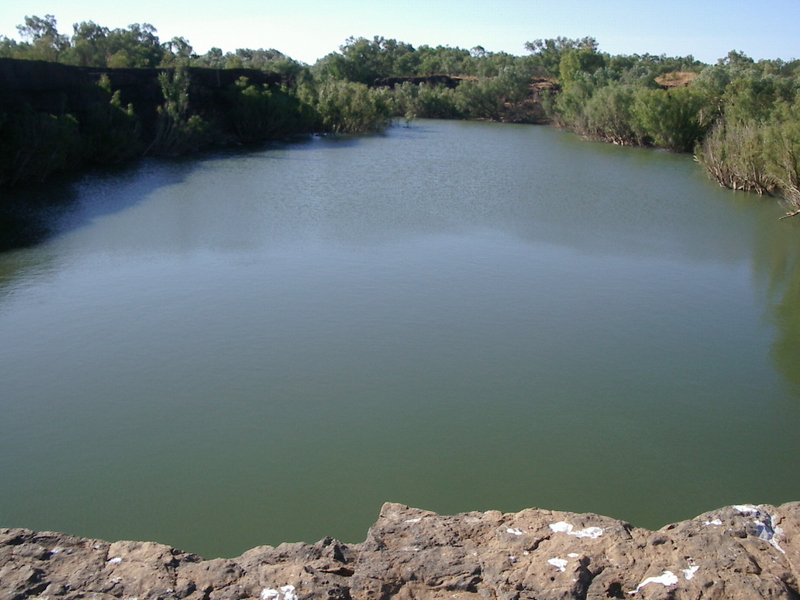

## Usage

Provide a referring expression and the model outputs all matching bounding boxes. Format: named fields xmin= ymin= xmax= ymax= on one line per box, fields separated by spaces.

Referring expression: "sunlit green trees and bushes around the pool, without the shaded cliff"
xmin=0 ymin=15 xmax=800 ymax=217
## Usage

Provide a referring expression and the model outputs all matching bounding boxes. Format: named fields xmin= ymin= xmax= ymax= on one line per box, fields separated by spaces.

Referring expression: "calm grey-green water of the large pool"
xmin=0 ymin=121 xmax=800 ymax=558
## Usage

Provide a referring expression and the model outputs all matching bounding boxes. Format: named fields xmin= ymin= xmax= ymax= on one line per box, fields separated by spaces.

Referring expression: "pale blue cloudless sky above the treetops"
xmin=0 ymin=0 xmax=800 ymax=64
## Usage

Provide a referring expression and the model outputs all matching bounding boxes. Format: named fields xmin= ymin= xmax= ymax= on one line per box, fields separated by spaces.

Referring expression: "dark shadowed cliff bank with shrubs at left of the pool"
xmin=0 ymin=58 xmax=300 ymax=187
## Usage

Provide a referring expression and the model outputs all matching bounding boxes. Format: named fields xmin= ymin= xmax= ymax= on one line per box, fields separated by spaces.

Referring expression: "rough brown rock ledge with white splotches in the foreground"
xmin=0 ymin=502 xmax=800 ymax=600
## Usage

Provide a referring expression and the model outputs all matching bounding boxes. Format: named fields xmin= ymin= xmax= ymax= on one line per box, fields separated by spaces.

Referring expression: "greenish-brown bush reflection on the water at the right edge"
xmin=753 ymin=211 xmax=800 ymax=394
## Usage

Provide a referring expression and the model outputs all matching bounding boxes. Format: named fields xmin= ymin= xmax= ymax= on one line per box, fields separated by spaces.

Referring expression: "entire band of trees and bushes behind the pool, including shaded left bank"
xmin=0 ymin=15 xmax=800 ymax=215
